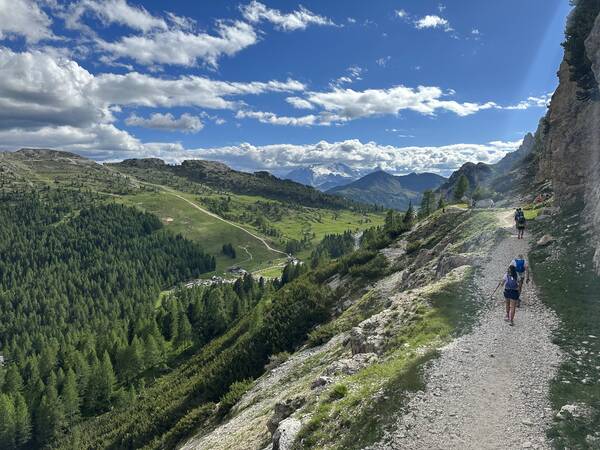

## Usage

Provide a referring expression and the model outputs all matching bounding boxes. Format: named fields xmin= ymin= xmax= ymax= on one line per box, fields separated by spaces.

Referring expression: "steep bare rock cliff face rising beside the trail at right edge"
xmin=536 ymin=8 xmax=600 ymax=272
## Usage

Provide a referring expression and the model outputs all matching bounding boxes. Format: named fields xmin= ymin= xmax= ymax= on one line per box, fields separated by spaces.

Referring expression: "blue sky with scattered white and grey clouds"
xmin=0 ymin=0 xmax=569 ymax=174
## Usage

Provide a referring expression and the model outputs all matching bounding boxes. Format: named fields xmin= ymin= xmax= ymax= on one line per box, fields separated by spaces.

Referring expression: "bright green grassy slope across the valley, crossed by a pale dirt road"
xmin=109 ymin=160 xmax=384 ymax=276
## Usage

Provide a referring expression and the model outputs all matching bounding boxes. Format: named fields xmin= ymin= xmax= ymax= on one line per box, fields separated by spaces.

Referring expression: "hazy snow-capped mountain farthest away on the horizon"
xmin=284 ymin=163 xmax=365 ymax=191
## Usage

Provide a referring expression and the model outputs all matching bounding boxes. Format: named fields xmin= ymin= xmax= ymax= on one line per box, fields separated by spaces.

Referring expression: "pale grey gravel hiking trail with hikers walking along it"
xmin=370 ymin=211 xmax=561 ymax=450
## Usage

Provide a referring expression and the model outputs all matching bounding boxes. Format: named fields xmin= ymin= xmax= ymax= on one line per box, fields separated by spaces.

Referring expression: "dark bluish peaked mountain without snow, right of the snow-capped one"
xmin=327 ymin=170 xmax=446 ymax=210
